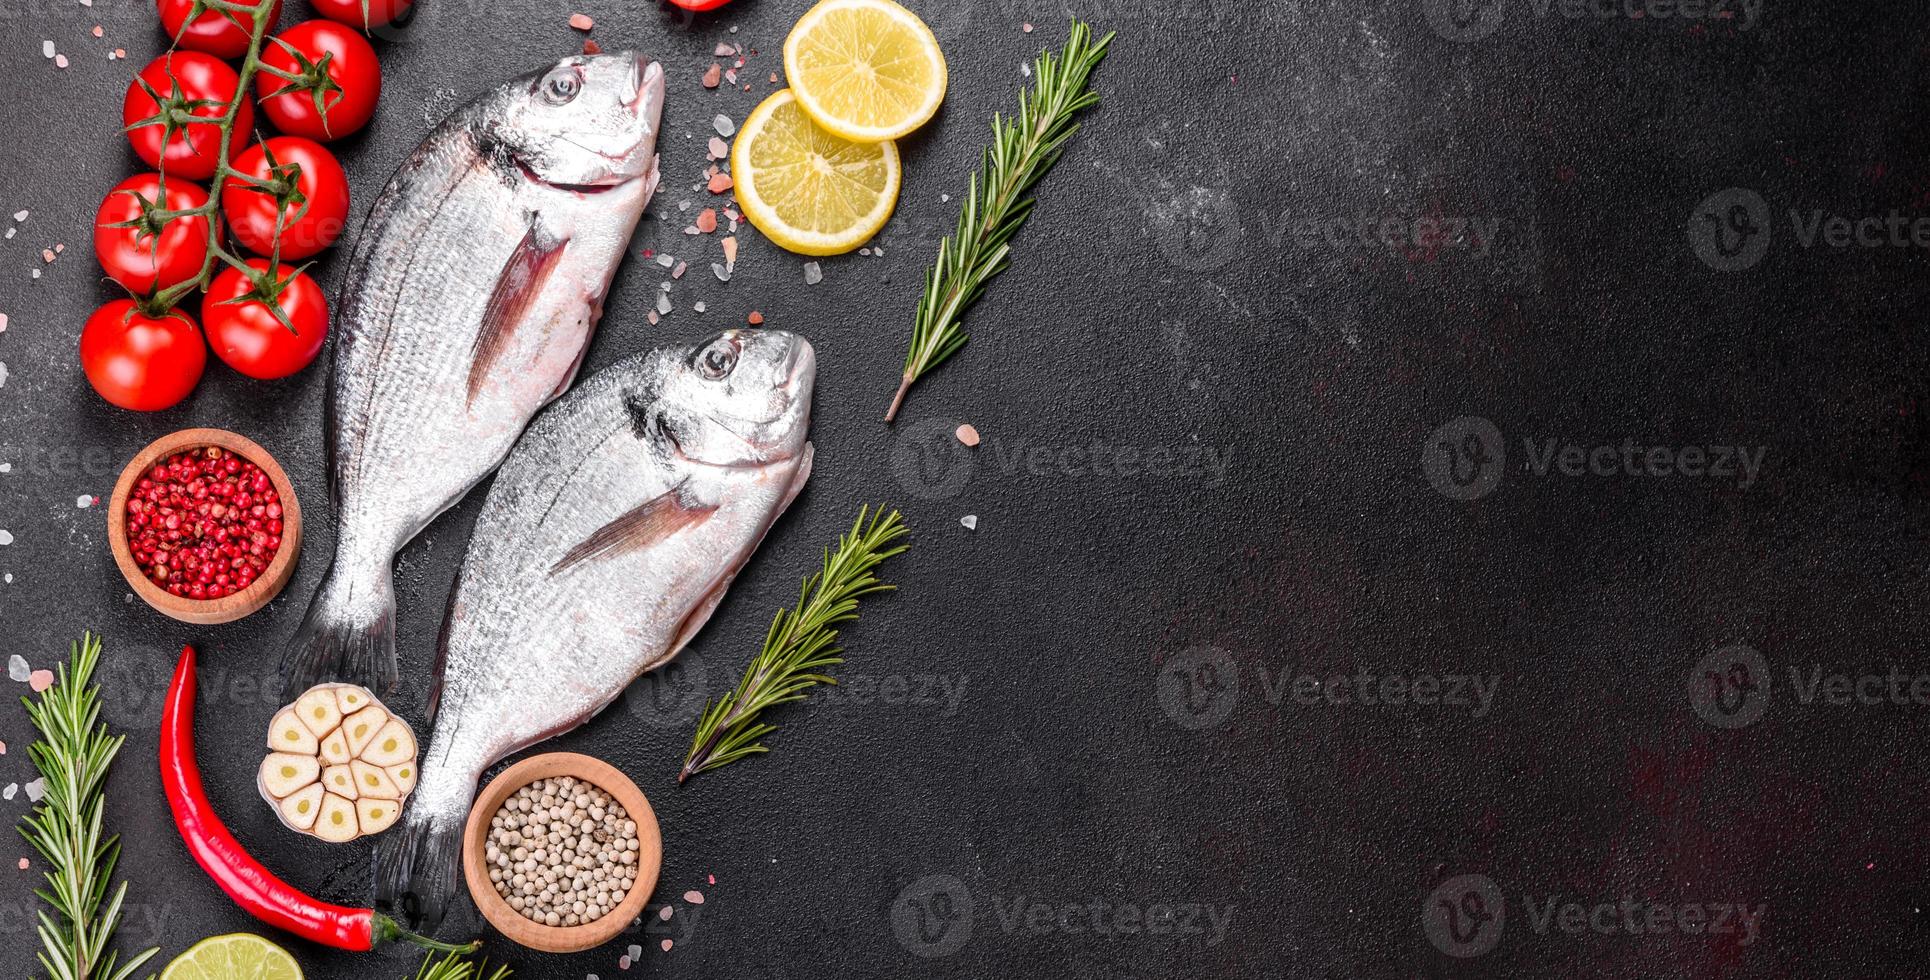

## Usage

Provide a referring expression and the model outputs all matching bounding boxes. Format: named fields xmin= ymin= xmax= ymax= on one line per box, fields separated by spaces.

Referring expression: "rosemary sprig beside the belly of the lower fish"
xmin=677 ymin=505 xmax=907 ymax=783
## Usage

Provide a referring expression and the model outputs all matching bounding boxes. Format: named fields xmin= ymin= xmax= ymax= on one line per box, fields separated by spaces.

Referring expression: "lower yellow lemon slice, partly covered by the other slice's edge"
xmin=730 ymin=89 xmax=901 ymax=255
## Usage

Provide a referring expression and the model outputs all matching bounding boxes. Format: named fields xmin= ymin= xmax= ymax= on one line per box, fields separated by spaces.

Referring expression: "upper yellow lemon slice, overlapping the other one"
xmin=784 ymin=0 xmax=941 ymax=143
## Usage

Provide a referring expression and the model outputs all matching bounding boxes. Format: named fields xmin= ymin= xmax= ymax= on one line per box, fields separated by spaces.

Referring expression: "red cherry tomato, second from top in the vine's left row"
xmin=122 ymin=50 xmax=255 ymax=179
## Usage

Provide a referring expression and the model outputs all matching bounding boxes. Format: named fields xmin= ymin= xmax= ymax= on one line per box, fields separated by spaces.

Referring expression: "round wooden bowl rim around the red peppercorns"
xmin=108 ymin=428 xmax=301 ymax=625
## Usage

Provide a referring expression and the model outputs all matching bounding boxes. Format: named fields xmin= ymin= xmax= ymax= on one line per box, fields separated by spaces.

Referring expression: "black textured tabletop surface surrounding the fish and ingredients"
xmin=0 ymin=0 xmax=1930 ymax=980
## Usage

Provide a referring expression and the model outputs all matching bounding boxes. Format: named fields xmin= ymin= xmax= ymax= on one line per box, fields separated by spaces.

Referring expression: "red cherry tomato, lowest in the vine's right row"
xmin=201 ymin=259 xmax=328 ymax=378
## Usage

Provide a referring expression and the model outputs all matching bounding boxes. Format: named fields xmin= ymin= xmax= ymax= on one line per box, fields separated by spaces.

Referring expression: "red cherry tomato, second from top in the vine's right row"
xmin=255 ymin=21 xmax=382 ymax=141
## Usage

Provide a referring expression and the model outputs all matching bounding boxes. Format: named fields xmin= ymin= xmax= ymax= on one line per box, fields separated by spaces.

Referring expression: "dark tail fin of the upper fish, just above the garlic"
xmin=282 ymin=558 xmax=396 ymax=694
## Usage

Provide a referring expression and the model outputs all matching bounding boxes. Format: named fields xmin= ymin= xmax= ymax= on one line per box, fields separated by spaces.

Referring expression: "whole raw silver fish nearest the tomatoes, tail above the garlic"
xmin=282 ymin=52 xmax=664 ymax=691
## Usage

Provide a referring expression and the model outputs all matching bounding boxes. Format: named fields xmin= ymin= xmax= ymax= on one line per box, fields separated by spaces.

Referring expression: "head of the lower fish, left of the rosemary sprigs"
xmin=639 ymin=330 xmax=818 ymax=467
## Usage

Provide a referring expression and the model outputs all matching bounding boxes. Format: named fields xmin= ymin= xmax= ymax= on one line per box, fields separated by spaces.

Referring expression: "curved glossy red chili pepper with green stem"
xmin=160 ymin=646 xmax=483 ymax=953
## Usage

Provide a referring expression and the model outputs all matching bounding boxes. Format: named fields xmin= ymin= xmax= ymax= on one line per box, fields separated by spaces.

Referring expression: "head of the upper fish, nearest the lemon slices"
xmin=484 ymin=52 xmax=664 ymax=189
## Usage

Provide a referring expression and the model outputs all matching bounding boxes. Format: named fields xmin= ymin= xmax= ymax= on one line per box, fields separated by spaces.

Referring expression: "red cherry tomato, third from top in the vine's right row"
xmin=222 ymin=137 xmax=349 ymax=259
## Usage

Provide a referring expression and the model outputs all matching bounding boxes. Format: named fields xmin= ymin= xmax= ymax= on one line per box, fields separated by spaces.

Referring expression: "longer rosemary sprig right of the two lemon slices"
xmin=884 ymin=17 xmax=1114 ymax=422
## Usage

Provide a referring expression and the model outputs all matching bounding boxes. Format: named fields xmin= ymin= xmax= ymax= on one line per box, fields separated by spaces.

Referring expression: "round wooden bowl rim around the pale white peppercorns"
xmin=463 ymin=752 xmax=664 ymax=953
